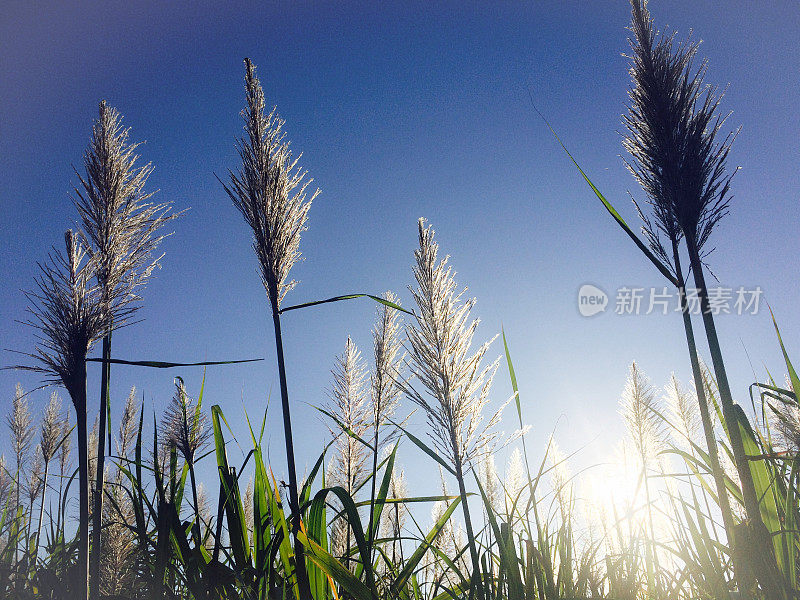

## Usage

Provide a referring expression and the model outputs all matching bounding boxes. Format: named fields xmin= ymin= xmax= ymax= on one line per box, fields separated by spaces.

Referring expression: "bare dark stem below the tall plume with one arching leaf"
xmin=270 ymin=304 xmax=311 ymax=600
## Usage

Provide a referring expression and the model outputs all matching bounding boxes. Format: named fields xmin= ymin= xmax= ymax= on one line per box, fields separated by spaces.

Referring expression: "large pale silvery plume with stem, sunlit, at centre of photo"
xmin=399 ymin=219 xmax=502 ymax=583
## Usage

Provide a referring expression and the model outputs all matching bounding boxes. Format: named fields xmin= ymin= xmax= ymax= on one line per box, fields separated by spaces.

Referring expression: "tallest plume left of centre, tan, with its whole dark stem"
xmin=223 ymin=59 xmax=319 ymax=597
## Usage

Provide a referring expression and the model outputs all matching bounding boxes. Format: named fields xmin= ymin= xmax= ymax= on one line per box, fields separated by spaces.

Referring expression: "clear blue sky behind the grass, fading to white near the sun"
xmin=0 ymin=0 xmax=800 ymax=502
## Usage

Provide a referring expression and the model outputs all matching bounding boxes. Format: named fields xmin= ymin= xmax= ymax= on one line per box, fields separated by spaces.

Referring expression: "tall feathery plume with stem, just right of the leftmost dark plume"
xmin=73 ymin=100 xmax=177 ymax=598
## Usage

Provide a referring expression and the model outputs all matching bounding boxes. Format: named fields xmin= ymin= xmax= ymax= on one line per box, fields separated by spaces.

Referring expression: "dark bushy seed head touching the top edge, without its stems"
xmin=623 ymin=0 xmax=736 ymax=264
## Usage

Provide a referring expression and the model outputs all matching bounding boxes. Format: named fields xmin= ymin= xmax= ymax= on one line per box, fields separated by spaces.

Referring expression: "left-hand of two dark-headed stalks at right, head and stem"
xmin=623 ymin=0 xmax=752 ymax=589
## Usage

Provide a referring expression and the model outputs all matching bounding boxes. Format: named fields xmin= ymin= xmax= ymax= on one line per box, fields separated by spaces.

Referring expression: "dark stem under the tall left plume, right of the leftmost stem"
xmin=89 ymin=332 xmax=111 ymax=600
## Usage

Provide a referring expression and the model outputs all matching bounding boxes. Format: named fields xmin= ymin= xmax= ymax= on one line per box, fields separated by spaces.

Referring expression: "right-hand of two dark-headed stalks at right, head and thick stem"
xmin=629 ymin=0 xmax=779 ymax=597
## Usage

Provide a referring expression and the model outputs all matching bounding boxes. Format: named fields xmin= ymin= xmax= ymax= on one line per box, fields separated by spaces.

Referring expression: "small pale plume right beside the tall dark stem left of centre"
xmin=329 ymin=336 xmax=370 ymax=562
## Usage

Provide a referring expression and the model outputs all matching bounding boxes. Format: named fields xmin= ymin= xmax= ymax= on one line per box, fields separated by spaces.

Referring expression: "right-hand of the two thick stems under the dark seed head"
xmin=686 ymin=238 xmax=783 ymax=598
